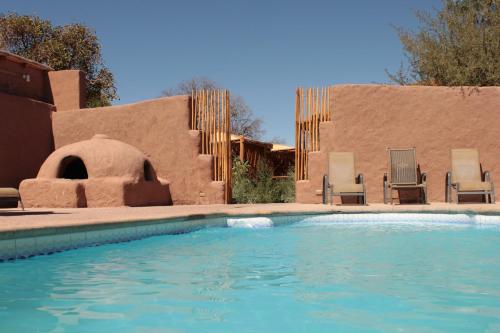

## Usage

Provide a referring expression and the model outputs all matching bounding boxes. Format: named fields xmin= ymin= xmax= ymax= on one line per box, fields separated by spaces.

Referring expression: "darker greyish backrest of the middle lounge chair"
xmin=388 ymin=148 xmax=418 ymax=185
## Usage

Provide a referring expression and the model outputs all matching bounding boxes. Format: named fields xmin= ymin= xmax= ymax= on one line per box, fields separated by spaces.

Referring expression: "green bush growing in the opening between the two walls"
xmin=233 ymin=158 xmax=295 ymax=203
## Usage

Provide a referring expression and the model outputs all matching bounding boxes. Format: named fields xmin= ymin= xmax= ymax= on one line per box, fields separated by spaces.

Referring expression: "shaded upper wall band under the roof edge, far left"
xmin=0 ymin=56 xmax=52 ymax=103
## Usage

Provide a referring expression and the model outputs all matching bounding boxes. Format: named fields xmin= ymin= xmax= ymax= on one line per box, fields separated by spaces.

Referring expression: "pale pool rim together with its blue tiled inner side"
xmin=0 ymin=204 xmax=500 ymax=262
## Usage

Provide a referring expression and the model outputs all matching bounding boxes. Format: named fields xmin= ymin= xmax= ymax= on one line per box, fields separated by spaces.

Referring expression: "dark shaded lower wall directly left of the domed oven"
xmin=0 ymin=92 xmax=54 ymax=187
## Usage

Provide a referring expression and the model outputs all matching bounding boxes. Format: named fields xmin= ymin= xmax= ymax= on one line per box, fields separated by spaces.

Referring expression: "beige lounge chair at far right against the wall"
xmin=446 ymin=149 xmax=495 ymax=203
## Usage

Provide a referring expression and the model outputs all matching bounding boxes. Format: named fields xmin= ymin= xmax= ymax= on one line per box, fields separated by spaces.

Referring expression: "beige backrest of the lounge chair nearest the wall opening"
xmin=328 ymin=152 xmax=356 ymax=185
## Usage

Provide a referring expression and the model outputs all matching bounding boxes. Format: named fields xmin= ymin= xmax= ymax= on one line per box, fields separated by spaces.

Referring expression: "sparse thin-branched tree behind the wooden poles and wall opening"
xmin=162 ymin=77 xmax=264 ymax=139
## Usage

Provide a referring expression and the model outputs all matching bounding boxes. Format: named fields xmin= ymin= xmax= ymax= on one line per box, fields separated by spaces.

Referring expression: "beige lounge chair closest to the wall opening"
xmin=323 ymin=152 xmax=366 ymax=205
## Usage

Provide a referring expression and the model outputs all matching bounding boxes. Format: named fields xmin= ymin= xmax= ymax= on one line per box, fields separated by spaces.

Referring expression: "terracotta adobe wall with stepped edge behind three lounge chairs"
xmin=297 ymin=85 xmax=500 ymax=203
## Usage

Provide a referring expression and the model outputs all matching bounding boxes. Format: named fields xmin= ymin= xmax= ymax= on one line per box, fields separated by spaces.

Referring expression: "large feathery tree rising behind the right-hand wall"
xmin=387 ymin=0 xmax=500 ymax=86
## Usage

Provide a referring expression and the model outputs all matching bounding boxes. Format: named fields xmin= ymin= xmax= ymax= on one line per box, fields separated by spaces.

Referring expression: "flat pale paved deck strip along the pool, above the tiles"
xmin=0 ymin=203 xmax=500 ymax=232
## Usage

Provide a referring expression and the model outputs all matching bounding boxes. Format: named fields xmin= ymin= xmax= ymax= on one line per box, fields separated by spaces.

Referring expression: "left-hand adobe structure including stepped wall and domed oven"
xmin=0 ymin=51 xmax=227 ymax=207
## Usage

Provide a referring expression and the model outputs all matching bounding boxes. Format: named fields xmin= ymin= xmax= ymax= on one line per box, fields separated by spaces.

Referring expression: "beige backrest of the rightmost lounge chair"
xmin=451 ymin=149 xmax=481 ymax=183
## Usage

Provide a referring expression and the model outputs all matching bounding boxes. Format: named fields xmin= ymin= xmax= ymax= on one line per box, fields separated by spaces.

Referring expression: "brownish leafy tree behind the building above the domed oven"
xmin=0 ymin=13 xmax=117 ymax=107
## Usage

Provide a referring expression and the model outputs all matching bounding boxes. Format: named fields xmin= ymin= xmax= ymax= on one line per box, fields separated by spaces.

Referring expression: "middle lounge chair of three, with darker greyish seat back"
xmin=384 ymin=148 xmax=427 ymax=205
